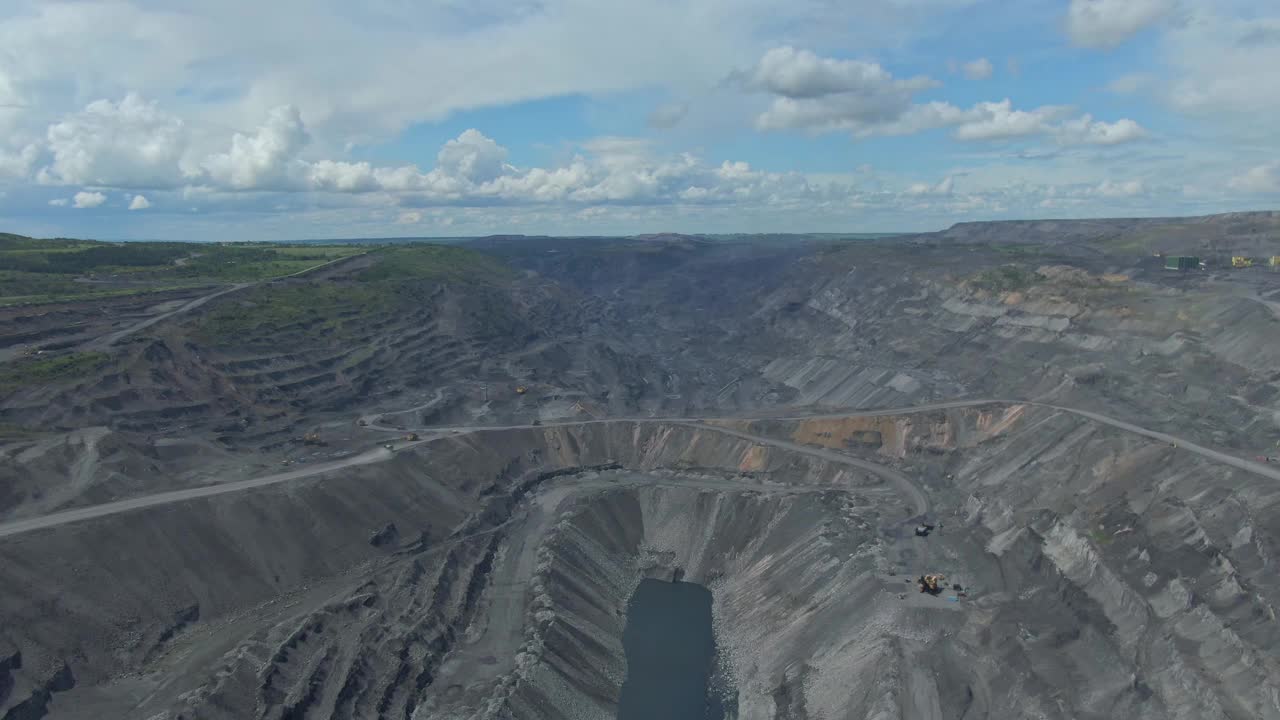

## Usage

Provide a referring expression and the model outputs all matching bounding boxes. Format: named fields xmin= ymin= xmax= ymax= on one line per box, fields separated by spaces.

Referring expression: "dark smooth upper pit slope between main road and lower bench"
xmin=0 ymin=423 xmax=874 ymax=716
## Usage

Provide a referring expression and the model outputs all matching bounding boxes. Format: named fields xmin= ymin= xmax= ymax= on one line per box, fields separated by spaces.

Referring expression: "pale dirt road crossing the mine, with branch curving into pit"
xmin=0 ymin=398 xmax=1280 ymax=538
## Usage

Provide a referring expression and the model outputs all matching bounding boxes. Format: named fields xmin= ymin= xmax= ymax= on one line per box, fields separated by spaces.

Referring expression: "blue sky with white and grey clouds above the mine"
xmin=0 ymin=0 xmax=1280 ymax=241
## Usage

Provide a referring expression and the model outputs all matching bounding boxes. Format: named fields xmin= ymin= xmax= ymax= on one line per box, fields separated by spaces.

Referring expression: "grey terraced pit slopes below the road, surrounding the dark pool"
xmin=0 ymin=406 xmax=1280 ymax=720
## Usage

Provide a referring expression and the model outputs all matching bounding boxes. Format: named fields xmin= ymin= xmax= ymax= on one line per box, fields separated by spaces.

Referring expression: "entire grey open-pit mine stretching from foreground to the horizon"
xmin=0 ymin=213 xmax=1280 ymax=720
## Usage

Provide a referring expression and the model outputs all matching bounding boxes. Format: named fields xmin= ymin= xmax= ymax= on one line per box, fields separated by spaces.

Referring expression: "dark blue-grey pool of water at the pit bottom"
xmin=618 ymin=579 xmax=724 ymax=720
